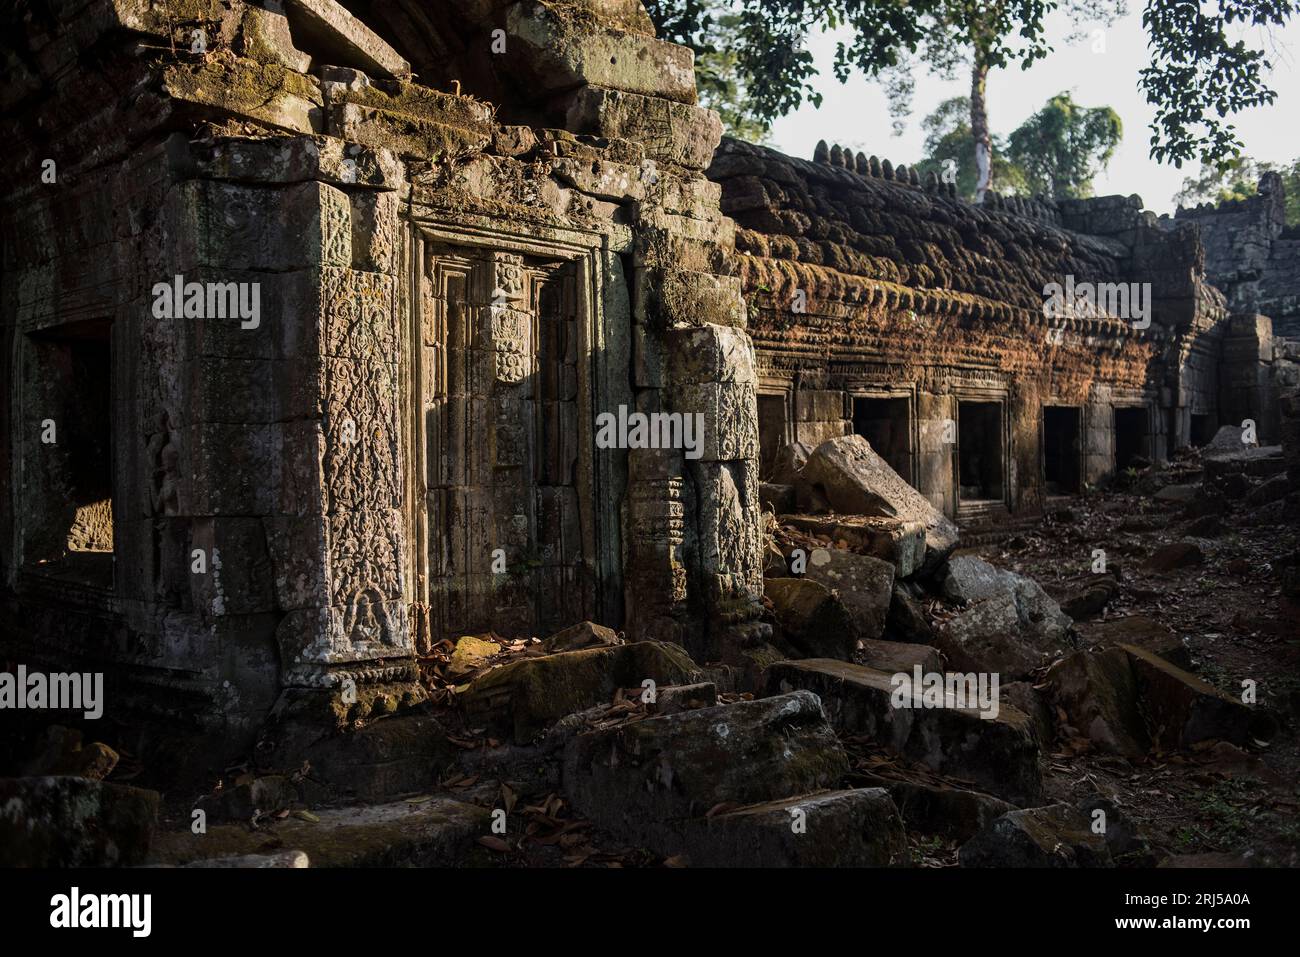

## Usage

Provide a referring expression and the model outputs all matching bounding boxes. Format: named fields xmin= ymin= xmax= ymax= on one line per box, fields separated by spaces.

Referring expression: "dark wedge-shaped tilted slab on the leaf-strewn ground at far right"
xmin=1121 ymin=645 xmax=1270 ymax=750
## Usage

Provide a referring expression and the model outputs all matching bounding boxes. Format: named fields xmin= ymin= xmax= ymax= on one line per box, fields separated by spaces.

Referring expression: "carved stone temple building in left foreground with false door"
xmin=0 ymin=0 xmax=762 ymax=761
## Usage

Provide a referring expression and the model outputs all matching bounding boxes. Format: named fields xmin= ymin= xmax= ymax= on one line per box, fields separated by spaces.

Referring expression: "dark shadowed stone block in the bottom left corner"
xmin=0 ymin=778 xmax=159 ymax=867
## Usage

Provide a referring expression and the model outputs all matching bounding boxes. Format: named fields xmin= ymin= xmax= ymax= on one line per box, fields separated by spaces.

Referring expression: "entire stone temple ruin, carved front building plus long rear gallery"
xmin=0 ymin=0 xmax=1300 ymax=863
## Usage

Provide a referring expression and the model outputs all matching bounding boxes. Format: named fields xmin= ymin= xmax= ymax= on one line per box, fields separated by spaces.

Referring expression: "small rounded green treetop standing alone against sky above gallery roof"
xmin=1008 ymin=92 xmax=1123 ymax=199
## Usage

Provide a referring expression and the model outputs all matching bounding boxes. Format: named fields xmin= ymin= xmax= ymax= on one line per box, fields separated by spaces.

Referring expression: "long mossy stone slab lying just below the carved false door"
xmin=462 ymin=641 xmax=699 ymax=744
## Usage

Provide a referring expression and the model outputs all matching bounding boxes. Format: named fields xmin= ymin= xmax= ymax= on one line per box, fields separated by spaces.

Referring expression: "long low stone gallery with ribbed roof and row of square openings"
xmin=709 ymin=139 xmax=1227 ymax=515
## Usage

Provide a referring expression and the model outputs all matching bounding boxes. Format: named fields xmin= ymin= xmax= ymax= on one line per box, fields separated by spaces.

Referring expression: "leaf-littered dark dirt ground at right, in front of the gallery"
xmin=926 ymin=462 xmax=1300 ymax=866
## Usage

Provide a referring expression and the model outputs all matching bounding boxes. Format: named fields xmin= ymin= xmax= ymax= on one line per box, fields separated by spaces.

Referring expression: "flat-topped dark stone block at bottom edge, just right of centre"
xmin=686 ymin=788 xmax=907 ymax=867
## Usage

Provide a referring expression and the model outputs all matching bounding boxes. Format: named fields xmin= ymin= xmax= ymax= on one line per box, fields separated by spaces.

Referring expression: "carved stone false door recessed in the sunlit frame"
xmin=416 ymin=241 xmax=597 ymax=641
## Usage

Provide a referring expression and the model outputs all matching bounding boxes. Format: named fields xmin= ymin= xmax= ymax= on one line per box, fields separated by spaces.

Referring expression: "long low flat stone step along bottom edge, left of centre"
xmin=151 ymin=794 xmax=491 ymax=867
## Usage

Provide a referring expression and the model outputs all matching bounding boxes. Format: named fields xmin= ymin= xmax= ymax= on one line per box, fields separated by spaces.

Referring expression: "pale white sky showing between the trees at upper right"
xmin=772 ymin=0 xmax=1300 ymax=213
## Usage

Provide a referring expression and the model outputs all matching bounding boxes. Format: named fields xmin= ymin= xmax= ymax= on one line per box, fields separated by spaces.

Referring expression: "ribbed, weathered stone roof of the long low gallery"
xmin=709 ymin=138 xmax=1132 ymax=332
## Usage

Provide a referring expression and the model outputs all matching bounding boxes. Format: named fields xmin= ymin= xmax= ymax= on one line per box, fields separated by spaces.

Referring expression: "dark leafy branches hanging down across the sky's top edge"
xmin=647 ymin=0 xmax=1300 ymax=185
